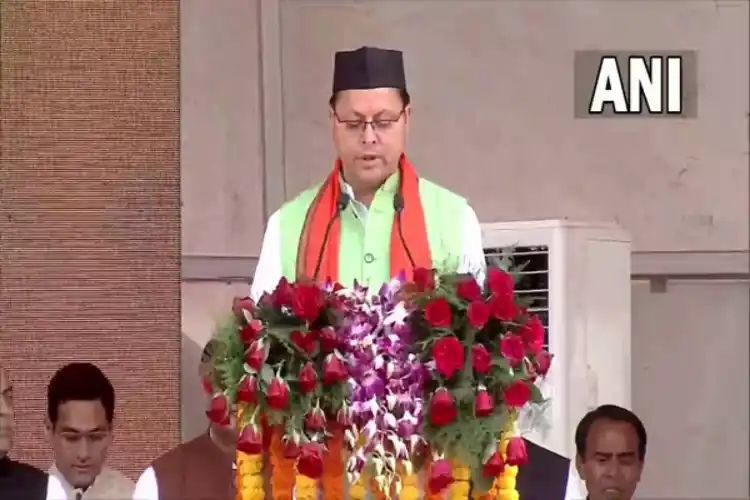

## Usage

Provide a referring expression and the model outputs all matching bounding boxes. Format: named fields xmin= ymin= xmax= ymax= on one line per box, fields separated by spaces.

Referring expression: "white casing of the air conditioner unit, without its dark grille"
xmin=482 ymin=220 xmax=631 ymax=457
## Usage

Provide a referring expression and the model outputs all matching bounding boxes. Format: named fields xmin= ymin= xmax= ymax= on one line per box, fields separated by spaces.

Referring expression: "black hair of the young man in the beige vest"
xmin=47 ymin=363 xmax=115 ymax=424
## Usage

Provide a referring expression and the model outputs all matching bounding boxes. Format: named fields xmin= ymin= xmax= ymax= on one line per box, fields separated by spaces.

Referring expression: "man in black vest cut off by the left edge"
xmin=0 ymin=366 xmax=65 ymax=500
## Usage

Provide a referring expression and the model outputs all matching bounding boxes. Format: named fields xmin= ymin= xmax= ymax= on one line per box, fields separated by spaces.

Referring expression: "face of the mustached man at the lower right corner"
xmin=576 ymin=420 xmax=643 ymax=500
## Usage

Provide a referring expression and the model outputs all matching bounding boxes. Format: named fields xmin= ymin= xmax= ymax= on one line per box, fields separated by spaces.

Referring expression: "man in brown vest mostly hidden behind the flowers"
xmin=133 ymin=342 xmax=237 ymax=500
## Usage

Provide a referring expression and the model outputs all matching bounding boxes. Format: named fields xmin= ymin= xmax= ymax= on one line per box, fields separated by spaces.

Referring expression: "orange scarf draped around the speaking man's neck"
xmin=297 ymin=155 xmax=432 ymax=283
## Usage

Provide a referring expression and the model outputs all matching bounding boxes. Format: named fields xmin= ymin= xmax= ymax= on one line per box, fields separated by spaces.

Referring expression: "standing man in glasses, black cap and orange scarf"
xmin=252 ymin=47 xmax=485 ymax=300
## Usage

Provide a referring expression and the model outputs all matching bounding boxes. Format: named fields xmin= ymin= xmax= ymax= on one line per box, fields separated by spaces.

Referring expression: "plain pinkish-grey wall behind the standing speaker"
xmin=182 ymin=0 xmax=750 ymax=498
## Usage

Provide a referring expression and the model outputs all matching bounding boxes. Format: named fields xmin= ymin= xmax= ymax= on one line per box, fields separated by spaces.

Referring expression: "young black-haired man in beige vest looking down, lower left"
xmin=46 ymin=363 xmax=135 ymax=500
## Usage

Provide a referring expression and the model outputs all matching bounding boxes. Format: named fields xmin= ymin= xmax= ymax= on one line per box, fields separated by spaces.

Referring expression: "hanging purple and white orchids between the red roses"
xmin=339 ymin=275 xmax=425 ymax=491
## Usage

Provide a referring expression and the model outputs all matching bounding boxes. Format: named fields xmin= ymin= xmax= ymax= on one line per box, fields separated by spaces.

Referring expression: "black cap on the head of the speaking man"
xmin=333 ymin=47 xmax=406 ymax=94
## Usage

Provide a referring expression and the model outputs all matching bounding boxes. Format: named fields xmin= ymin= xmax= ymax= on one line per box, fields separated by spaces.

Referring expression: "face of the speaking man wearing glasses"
xmin=331 ymin=88 xmax=410 ymax=196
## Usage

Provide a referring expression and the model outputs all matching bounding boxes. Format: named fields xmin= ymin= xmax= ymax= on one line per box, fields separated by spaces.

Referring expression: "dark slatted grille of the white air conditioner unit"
xmin=484 ymin=246 xmax=549 ymax=346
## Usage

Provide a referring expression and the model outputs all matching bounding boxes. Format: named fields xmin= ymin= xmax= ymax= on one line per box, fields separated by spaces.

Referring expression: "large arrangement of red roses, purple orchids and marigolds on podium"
xmin=206 ymin=268 xmax=552 ymax=500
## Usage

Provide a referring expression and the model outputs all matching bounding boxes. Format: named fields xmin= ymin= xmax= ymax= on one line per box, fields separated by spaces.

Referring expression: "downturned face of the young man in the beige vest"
xmin=47 ymin=401 xmax=112 ymax=488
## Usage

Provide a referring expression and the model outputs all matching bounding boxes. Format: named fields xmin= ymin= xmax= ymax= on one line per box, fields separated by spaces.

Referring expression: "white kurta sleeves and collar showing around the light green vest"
xmin=250 ymin=183 xmax=487 ymax=301
